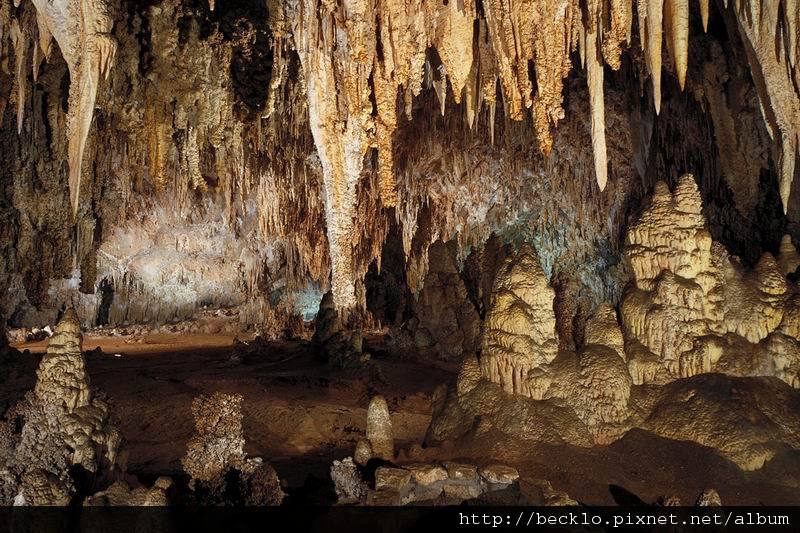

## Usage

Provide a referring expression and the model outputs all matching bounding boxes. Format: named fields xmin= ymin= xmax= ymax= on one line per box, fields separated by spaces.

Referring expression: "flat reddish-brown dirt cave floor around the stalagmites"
xmin=6 ymin=335 xmax=800 ymax=505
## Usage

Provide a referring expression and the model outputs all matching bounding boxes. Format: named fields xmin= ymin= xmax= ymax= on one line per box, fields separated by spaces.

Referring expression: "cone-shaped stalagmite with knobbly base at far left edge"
xmin=2 ymin=309 xmax=124 ymax=505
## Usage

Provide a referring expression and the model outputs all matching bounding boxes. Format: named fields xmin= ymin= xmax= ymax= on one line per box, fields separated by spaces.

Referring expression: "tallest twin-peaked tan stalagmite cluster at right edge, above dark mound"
xmin=621 ymin=175 xmax=800 ymax=387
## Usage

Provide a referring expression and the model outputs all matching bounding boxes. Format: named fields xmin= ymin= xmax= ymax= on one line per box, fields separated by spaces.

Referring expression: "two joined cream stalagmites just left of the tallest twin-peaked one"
xmin=480 ymin=264 xmax=632 ymax=444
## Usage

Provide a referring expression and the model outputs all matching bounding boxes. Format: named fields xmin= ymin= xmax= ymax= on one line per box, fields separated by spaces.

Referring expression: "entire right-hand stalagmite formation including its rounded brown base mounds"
xmin=428 ymin=175 xmax=800 ymax=470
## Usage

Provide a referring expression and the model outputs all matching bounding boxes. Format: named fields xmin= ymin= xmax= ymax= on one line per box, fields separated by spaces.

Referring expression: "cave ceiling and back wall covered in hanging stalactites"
xmin=0 ymin=0 xmax=800 ymax=323
